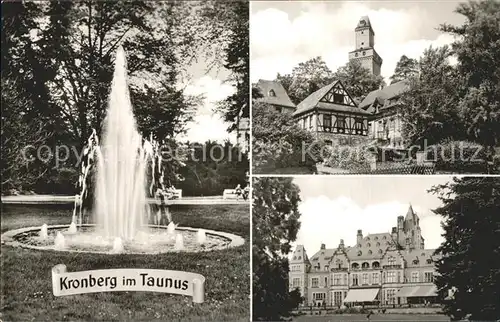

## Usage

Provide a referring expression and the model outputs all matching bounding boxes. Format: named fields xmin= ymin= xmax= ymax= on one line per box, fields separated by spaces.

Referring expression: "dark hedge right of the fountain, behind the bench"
xmin=175 ymin=141 xmax=249 ymax=196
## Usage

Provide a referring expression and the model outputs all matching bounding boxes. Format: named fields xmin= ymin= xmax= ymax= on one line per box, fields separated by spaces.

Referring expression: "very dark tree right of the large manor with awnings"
xmin=430 ymin=177 xmax=500 ymax=321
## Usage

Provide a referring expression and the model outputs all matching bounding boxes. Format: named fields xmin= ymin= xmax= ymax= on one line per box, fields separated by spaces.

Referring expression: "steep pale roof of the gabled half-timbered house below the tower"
xmin=293 ymin=80 xmax=368 ymax=116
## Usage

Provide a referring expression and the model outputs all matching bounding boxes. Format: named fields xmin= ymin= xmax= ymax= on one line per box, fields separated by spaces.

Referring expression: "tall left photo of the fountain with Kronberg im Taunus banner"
xmin=0 ymin=1 xmax=251 ymax=321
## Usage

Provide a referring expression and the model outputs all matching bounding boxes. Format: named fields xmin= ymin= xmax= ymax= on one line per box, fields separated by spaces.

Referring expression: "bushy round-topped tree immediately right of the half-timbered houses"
xmin=399 ymin=46 xmax=466 ymax=146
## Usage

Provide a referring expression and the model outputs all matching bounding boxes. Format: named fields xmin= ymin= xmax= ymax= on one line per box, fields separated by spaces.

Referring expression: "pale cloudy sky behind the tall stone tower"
xmin=250 ymin=0 xmax=464 ymax=83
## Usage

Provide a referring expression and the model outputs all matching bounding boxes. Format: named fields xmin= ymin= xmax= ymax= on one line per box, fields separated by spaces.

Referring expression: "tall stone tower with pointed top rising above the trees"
xmin=349 ymin=16 xmax=382 ymax=76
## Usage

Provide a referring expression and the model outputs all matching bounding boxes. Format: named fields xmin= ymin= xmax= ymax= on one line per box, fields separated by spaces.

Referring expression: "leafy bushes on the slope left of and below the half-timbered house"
xmin=252 ymin=102 xmax=322 ymax=170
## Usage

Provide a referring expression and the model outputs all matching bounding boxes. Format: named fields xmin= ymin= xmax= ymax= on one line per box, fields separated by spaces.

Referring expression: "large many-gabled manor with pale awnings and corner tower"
xmin=289 ymin=206 xmax=437 ymax=307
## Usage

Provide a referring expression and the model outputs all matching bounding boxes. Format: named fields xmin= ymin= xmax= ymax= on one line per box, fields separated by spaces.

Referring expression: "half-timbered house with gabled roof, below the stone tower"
xmin=293 ymin=80 xmax=370 ymax=145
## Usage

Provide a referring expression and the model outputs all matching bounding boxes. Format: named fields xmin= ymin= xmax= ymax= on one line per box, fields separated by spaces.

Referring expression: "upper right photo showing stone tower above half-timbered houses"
xmin=250 ymin=0 xmax=500 ymax=175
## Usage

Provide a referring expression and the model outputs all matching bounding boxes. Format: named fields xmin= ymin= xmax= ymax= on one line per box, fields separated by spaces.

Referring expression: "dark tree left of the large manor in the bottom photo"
xmin=252 ymin=178 xmax=300 ymax=321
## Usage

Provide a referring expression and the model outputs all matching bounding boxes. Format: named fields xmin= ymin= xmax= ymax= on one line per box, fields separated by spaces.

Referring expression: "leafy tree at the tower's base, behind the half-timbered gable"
xmin=334 ymin=60 xmax=384 ymax=103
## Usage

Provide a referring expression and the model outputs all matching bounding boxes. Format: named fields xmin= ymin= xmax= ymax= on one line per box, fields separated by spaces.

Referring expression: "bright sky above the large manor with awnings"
xmin=294 ymin=176 xmax=458 ymax=256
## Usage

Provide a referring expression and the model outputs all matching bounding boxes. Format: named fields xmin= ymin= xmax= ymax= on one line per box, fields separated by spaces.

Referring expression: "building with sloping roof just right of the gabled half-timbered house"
xmin=359 ymin=80 xmax=409 ymax=148
